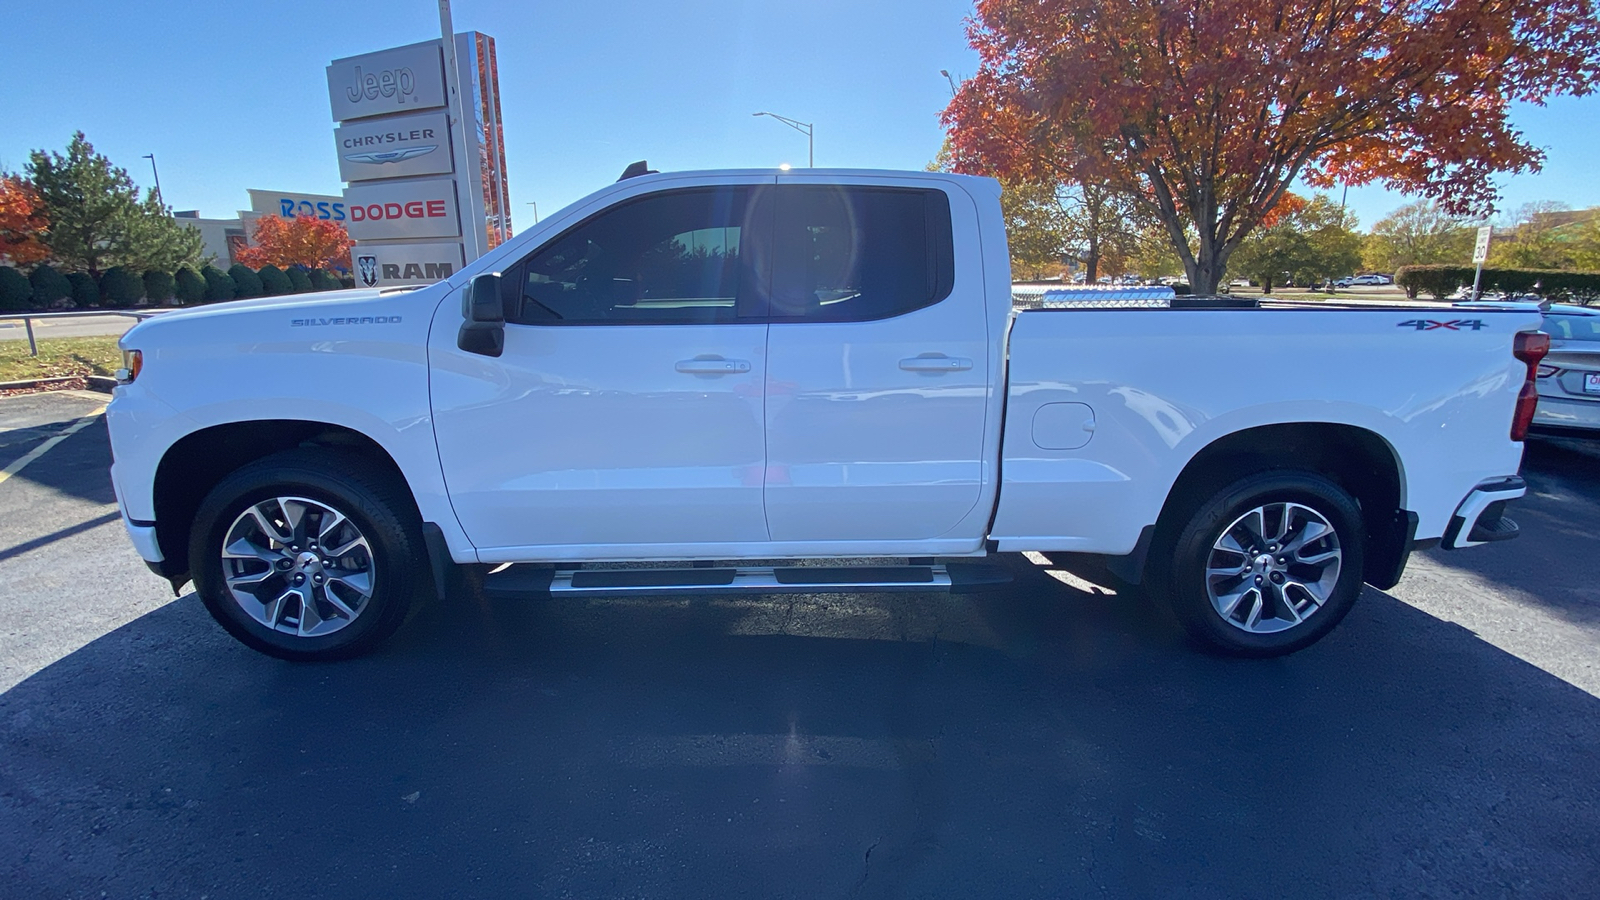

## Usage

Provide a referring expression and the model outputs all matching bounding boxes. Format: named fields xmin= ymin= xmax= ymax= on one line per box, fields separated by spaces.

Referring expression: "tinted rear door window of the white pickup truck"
xmin=770 ymin=186 xmax=955 ymax=322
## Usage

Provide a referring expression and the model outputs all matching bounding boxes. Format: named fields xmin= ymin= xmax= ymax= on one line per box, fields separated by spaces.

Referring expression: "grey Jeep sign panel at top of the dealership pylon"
xmin=328 ymin=40 xmax=445 ymax=122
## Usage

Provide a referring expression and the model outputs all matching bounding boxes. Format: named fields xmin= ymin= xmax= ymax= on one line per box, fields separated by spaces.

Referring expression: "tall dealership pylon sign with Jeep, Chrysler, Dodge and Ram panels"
xmin=328 ymin=32 xmax=510 ymax=287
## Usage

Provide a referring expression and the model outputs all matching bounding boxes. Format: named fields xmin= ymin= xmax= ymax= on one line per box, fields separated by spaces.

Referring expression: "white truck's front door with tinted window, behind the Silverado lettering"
xmin=430 ymin=186 xmax=770 ymax=560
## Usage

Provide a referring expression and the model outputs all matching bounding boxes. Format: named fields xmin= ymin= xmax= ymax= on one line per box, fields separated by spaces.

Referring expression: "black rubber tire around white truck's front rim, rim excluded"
xmin=189 ymin=448 xmax=429 ymax=661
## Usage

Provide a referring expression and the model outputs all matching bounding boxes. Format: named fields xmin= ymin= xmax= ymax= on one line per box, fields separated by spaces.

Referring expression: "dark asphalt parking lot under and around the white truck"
xmin=0 ymin=394 xmax=1600 ymax=898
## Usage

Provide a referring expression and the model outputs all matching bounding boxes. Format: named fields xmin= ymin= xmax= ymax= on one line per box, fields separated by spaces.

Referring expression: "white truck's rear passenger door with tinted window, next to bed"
xmin=765 ymin=176 xmax=989 ymax=541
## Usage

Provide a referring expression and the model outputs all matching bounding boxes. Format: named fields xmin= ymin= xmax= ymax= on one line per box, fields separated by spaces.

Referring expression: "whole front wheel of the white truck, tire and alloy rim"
xmin=189 ymin=450 xmax=424 ymax=661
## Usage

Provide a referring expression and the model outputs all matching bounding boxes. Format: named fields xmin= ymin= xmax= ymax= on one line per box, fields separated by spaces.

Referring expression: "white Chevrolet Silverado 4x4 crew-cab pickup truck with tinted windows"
xmin=109 ymin=170 xmax=1547 ymax=660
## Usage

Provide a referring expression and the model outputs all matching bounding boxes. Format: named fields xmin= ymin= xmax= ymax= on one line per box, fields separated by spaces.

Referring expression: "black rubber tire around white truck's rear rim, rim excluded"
xmin=1152 ymin=469 xmax=1366 ymax=658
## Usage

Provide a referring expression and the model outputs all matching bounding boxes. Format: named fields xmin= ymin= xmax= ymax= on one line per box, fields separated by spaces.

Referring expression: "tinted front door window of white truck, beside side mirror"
xmin=506 ymin=187 xmax=757 ymax=325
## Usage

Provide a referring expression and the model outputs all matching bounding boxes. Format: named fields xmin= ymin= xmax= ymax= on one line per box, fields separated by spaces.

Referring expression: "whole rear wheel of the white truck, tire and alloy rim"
xmin=1160 ymin=471 xmax=1363 ymax=657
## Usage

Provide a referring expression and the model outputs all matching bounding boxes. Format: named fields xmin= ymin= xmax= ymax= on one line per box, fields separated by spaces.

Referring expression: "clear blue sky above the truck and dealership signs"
xmin=0 ymin=0 xmax=1600 ymax=231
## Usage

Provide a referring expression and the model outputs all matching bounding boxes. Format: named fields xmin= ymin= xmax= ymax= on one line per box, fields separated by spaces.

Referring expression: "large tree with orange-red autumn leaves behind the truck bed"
xmin=944 ymin=0 xmax=1600 ymax=293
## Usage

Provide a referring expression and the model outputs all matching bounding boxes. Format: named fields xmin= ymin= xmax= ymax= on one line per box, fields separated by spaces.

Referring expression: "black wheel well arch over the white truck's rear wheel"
xmin=1150 ymin=423 xmax=1416 ymax=588
